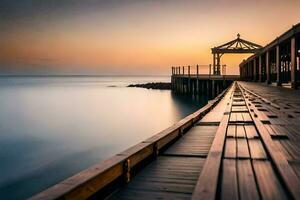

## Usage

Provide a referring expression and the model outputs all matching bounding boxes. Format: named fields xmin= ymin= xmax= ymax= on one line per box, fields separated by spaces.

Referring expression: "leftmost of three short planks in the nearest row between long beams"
xmin=221 ymin=159 xmax=238 ymax=200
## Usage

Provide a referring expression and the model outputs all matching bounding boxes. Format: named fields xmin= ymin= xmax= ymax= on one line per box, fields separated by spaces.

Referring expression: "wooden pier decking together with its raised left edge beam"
xmin=32 ymin=82 xmax=300 ymax=199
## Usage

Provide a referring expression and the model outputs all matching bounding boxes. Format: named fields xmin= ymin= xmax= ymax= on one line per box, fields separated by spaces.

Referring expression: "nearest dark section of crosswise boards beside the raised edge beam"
xmin=112 ymin=156 xmax=205 ymax=199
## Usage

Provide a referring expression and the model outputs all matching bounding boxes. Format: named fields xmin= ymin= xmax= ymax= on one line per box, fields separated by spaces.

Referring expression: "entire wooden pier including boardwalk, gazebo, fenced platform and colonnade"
xmin=31 ymin=24 xmax=300 ymax=200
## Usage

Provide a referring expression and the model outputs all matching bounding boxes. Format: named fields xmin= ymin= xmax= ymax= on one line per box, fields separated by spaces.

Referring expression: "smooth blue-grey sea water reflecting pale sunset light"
xmin=0 ymin=77 xmax=207 ymax=199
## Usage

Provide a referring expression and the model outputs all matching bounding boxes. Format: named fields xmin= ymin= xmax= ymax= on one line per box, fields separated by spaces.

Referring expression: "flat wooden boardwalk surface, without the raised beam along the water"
xmin=112 ymin=83 xmax=300 ymax=199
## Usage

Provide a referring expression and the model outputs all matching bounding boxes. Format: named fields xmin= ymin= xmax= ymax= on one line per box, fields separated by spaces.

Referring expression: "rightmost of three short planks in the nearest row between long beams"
xmin=253 ymin=160 xmax=288 ymax=200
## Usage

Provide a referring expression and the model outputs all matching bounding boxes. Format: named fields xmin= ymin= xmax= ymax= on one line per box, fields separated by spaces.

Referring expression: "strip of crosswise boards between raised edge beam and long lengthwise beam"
xmin=112 ymin=85 xmax=237 ymax=199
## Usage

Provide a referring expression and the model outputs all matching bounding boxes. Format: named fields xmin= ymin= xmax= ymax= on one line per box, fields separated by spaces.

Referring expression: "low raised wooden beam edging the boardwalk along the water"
xmin=30 ymin=83 xmax=231 ymax=200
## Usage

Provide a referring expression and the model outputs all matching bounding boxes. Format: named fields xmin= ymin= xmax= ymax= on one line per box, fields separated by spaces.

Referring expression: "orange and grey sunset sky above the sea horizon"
xmin=0 ymin=0 xmax=300 ymax=75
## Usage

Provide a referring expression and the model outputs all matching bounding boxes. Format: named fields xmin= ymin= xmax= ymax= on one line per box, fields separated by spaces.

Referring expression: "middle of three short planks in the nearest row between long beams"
xmin=237 ymin=160 xmax=259 ymax=200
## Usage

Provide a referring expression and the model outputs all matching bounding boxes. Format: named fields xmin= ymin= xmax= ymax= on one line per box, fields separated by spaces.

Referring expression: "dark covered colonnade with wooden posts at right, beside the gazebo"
xmin=240 ymin=23 xmax=300 ymax=88
